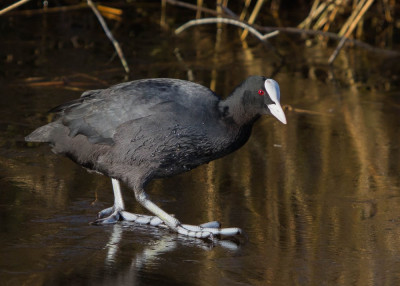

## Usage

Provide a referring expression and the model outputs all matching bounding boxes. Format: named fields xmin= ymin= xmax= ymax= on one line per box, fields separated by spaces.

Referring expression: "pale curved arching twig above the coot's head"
xmin=175 ymin=18 xmax=279 ymax=41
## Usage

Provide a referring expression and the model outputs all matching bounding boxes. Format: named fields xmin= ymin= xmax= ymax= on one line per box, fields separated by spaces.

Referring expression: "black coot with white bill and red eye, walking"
xmin=25 ymin=76 xmax=286 ymax=238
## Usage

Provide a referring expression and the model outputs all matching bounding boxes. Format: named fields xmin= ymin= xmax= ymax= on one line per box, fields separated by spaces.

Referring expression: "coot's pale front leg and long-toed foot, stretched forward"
xmin=134 ymin=183 xmax=242 ymax=239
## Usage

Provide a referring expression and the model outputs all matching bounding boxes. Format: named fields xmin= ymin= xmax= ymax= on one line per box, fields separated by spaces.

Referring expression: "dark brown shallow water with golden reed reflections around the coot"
xmin=0 ymin=2 xmax=400 ymax=285
